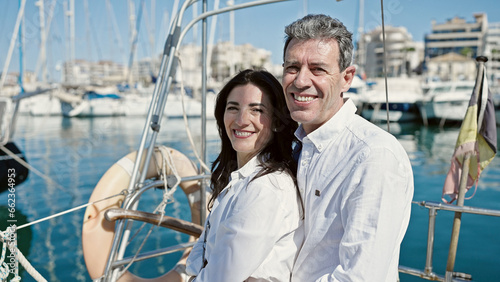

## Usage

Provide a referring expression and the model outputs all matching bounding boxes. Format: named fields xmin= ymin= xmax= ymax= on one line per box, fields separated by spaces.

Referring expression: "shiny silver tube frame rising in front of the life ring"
xmin=101 ymin=0 xmax=289 ymax=281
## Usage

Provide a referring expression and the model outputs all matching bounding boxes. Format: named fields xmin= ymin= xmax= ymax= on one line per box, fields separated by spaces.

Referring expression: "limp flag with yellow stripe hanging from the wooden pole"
xmin=442 ymin=64 xmax=497 ymax=203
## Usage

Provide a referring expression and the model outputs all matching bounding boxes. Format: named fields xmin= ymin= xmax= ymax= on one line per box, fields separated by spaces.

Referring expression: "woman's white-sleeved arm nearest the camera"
xmin=195 ymin=179 xmax=285 ymax=282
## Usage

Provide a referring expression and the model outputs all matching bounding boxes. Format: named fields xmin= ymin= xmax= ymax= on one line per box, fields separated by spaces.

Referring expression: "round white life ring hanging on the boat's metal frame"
xmin=82 ymin=147 xmax=205 ymax=281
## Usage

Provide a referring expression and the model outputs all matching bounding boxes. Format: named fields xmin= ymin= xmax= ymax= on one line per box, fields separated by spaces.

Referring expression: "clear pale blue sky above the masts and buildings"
xmin=0 ymin=0 xmax=500 ymax=81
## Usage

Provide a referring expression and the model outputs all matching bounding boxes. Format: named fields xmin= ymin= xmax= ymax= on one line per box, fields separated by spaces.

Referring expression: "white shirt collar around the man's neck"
xmin=295 ymin=99 xmax=356 ymax=152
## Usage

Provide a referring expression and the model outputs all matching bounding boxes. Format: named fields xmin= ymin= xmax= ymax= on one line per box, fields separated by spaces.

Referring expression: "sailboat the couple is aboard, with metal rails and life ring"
xmin=1 ymin=0 xmax=498 ymax=281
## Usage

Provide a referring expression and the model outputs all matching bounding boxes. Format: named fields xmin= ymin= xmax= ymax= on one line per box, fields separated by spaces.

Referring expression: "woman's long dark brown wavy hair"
xmin=208 ymin=69 xmax=300 ymax=213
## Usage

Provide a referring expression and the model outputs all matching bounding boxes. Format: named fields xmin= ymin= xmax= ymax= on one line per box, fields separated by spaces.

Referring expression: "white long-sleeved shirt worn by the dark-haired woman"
xmin=187 ymin=157 xmax=303 ymax=282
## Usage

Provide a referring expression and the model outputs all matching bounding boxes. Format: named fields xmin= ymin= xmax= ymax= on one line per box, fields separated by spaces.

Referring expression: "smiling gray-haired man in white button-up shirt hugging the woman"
xmin=282 ymin=15 xmax=413 ymax=282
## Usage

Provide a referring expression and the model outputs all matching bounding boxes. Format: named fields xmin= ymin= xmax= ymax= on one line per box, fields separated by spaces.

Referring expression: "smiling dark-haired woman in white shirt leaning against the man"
xmin=187 ymin=70 xmax=303 ymax=282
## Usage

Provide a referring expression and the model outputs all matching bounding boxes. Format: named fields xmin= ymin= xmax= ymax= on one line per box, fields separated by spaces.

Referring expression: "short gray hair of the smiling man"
xmin=283 ymin=14 xmax=353 ymax=71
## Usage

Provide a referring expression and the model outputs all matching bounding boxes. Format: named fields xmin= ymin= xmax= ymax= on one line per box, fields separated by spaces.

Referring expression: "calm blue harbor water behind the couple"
xmin=0 ymin=116 xmax=500 ymax=282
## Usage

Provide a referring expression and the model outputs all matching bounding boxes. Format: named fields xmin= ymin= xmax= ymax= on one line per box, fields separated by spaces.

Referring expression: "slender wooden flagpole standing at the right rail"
xmin=445 ymin=56 xmax=488 ymax=282
